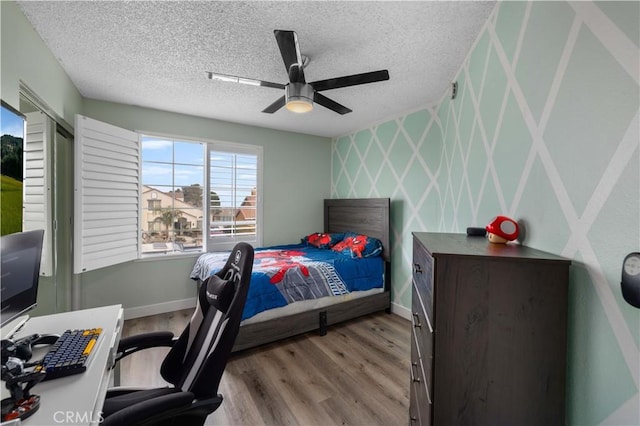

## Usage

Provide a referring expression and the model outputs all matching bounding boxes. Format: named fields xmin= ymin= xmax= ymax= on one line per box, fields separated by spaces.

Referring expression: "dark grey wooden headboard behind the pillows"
xmin=324 ymin=198 xmax=391 ymax=262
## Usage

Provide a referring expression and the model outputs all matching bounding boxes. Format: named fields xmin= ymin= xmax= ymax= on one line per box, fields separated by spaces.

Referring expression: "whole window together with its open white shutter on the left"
xmin=74 ymin=115 xmax=262 ymax=273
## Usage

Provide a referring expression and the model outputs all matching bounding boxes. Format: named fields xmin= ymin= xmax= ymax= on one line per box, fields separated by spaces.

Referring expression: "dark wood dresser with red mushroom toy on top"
xmin=409 ymin=232 xmax=571 ymax=426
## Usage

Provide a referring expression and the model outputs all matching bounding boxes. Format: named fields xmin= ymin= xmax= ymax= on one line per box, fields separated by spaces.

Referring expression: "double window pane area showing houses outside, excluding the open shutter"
xmin=140 ymin=136 xmax=261 ymax=255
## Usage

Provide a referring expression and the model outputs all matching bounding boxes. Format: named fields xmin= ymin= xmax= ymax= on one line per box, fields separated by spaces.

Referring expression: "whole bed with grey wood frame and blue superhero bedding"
xmin=191 ymin=198 xmax=391 ymax=351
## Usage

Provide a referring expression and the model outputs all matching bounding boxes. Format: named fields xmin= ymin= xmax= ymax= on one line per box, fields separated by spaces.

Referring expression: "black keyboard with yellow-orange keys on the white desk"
xmin=35 ymin=328 xmax=102 ymax=380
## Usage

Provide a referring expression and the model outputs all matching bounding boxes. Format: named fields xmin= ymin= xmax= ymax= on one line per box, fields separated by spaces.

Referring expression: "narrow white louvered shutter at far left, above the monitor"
xmin=22 ymin=111 xmax=53 ymax=277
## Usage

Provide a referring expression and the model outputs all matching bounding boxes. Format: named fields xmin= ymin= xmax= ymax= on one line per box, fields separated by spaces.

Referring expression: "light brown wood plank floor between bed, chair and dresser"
xmin=120 ymin=311 xmax=410 ymax=426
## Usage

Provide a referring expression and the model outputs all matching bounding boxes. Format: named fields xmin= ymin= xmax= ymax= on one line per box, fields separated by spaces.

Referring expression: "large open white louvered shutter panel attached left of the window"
xmin=74 ymin=115 xmax=140 ymax=274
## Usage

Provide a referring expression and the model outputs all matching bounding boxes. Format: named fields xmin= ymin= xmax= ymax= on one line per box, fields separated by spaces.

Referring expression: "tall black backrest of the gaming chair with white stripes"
xmin=160 ymin=243 xmax=253 ymax=399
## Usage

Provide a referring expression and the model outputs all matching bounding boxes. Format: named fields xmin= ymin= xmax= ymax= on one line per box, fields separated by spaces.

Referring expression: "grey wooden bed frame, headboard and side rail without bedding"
xmin=233 ymin=198 xmax=391 ymax=352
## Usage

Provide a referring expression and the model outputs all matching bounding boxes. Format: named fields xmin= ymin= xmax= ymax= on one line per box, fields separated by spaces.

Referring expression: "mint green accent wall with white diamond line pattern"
xmin=332 ymin=1 xmax=640 ymax=425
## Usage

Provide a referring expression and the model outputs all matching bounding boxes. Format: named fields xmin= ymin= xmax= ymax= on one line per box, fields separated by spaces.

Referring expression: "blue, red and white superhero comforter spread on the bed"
xmin=191 ymin=244 xmax=384 ymax=320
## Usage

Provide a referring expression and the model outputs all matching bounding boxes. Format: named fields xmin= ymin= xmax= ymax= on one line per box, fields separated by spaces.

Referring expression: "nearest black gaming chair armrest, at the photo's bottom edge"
xmin=100 ymin=392 xmax=194 ymax=426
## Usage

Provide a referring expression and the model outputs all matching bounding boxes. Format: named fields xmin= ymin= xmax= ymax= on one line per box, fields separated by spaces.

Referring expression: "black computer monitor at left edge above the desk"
xmin=0 ymin=229 xmax=44 ymax=332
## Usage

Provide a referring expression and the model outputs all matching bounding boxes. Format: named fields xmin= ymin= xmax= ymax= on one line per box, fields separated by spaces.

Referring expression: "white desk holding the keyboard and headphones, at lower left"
xmin=2 ymin=305 xmax=124 ymax=426
